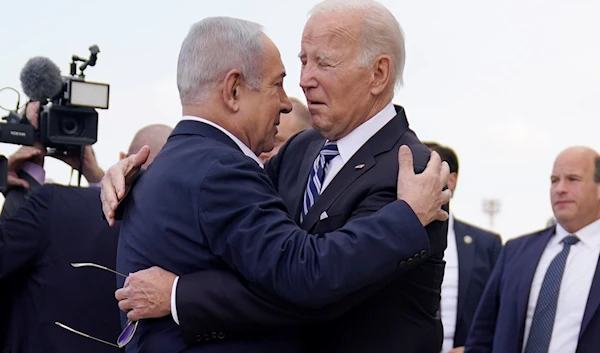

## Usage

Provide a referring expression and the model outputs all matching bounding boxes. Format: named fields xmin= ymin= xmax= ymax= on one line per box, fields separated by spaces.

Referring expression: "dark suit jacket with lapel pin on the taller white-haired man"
xmin=177 ymin=107 xmax=447 ymax=353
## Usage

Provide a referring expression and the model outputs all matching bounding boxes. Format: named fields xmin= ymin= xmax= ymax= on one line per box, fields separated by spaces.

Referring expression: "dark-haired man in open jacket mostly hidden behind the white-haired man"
xmin=425 ymin=142 xmax=502 ymax=353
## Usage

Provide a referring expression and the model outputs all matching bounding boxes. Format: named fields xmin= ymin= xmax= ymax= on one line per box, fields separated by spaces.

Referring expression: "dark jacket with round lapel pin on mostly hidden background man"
xmin=454 ymin=219 xmax=502 ymax=347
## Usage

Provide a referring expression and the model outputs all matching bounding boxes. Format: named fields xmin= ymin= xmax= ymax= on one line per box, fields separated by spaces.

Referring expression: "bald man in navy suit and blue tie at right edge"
xmin=465 ymin=146 xmax=600 ymax=353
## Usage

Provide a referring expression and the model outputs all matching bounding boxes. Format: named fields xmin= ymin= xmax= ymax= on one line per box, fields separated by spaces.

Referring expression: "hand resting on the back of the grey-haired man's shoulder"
xmin=100 ymin=146 xmax=150 ymax=226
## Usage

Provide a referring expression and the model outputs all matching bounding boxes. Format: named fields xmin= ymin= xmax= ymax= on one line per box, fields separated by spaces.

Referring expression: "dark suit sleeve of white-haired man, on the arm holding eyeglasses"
xmin=176 ymin=184 xmax=432 ymax=342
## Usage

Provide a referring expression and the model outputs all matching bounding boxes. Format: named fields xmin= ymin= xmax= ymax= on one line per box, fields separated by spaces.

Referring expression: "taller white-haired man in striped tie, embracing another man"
xmin=103 ymin=1 xmax=448 ymax=353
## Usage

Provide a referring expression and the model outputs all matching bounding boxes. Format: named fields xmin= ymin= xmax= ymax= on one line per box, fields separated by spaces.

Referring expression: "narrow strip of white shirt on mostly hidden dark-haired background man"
xmin=440 ymin=213 xmax=458 ymax=353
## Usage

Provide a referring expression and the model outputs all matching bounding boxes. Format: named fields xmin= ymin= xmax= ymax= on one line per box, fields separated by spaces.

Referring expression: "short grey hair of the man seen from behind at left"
xmin=177 ymin=17 xmax=264 ymax=104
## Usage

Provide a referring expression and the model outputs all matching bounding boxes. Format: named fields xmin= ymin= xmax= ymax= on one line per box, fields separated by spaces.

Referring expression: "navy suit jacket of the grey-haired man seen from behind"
xmin=117 ymin=121 xmax=434 ymax=353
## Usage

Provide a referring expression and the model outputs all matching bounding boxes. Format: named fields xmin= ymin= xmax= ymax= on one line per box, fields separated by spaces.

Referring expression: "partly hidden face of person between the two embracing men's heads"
xmin=259 ymin=97 xmax=311 ymax=163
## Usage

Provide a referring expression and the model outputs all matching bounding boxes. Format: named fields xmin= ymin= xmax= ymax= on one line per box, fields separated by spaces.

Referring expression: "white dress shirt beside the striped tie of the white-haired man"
xmin=321 ymin=102 xmax=396 ymax=193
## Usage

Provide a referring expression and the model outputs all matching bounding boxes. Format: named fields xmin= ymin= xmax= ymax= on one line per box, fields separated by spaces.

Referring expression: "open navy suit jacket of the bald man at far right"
xmin=465 ymin=226 xmax=600 ymax=353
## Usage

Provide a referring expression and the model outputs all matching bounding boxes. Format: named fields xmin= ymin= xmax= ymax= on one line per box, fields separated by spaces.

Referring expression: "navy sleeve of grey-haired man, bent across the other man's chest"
xmin=198 ymin=155 xmax=429 ymax=308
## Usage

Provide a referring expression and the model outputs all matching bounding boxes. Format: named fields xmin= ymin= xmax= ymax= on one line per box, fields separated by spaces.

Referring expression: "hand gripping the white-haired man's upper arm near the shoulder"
xmin=397 ymin=145 xmax=452 ymax=226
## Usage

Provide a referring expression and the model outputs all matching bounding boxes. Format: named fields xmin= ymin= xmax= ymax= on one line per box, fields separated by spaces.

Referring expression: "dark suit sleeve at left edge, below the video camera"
xmin=0 ymin=187 xmax=51 ymax=279
